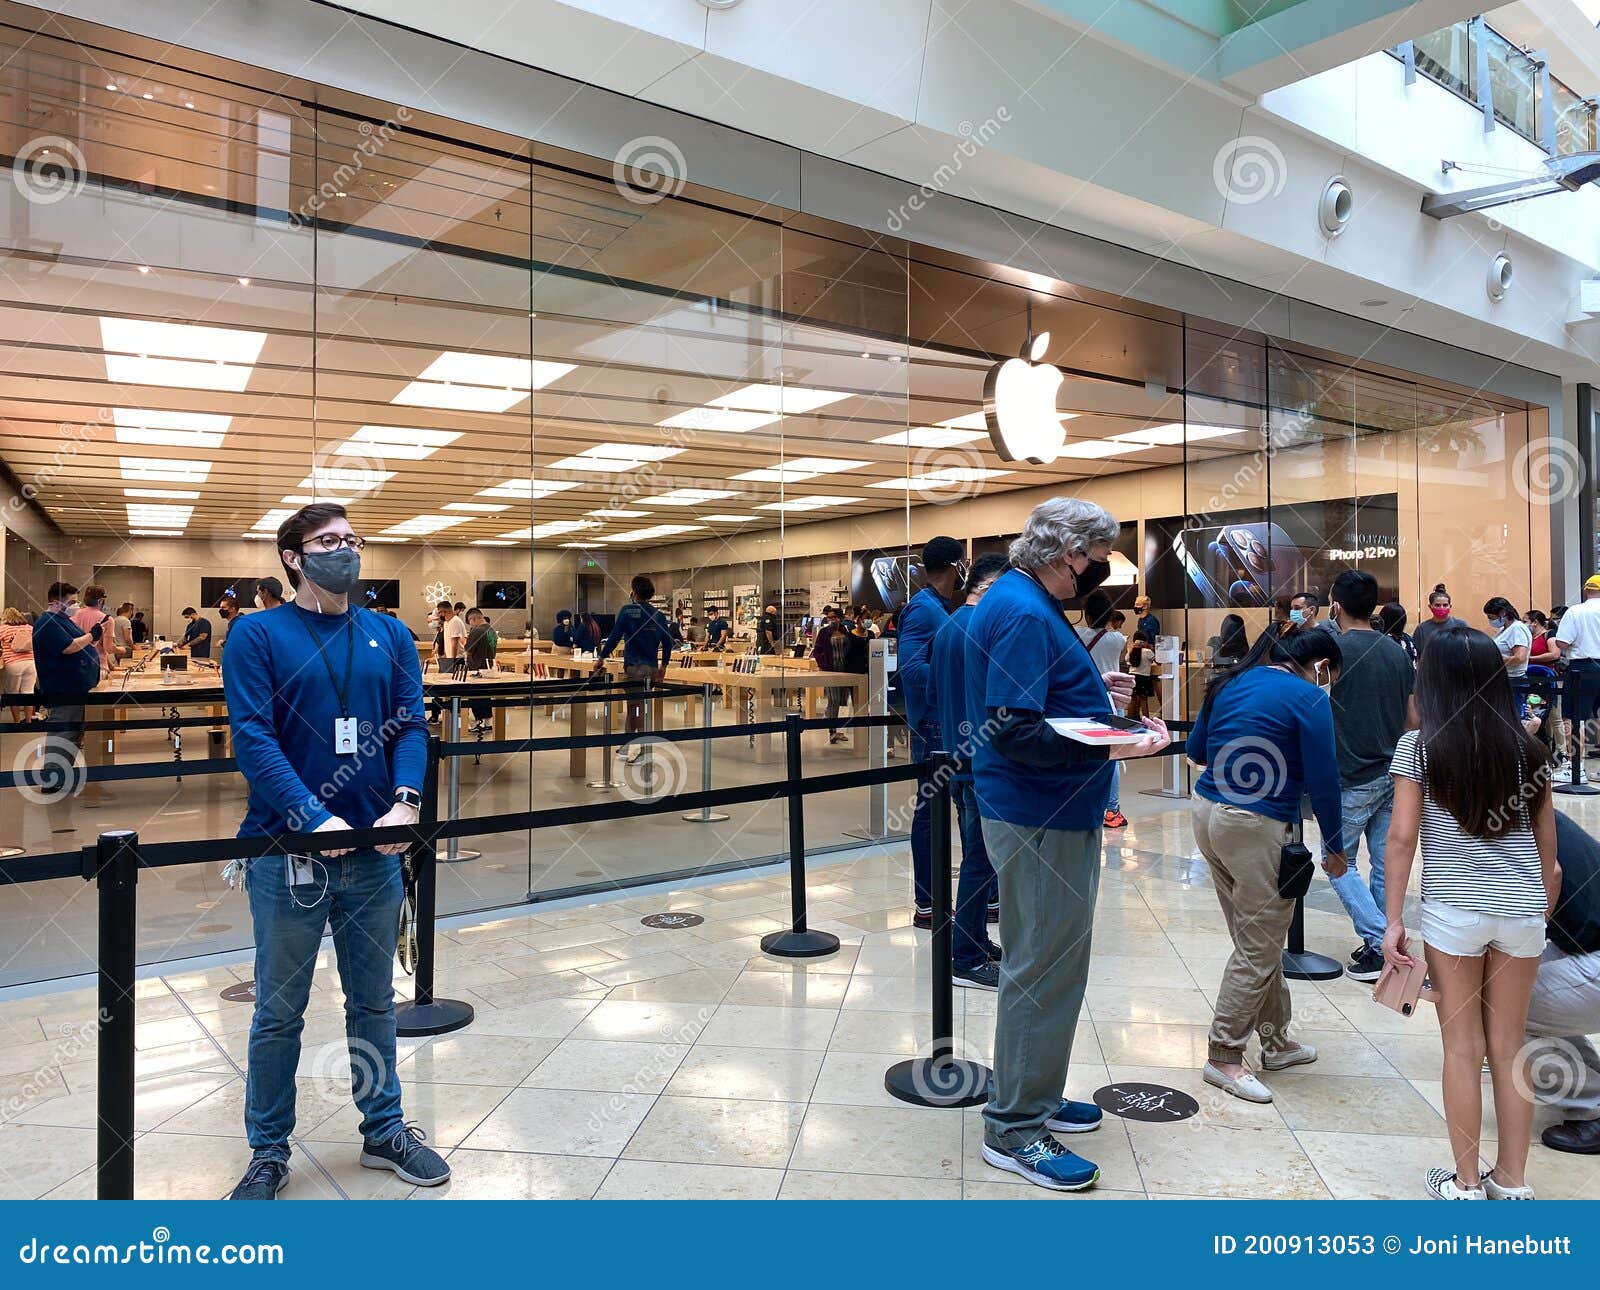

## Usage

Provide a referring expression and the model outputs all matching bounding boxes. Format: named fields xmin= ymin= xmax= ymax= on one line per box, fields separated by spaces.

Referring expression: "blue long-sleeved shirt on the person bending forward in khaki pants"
xmin=1186 ymin=667 xmax=1344 ymax=847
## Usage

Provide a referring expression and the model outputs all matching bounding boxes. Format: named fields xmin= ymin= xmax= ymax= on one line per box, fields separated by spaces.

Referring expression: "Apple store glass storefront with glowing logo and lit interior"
xmin=0 ymin=29 xmax=1549 ymax=988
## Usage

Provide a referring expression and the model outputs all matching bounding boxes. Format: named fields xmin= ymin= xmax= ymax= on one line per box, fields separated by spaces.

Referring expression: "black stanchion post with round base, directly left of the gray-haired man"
xmin=883 ymin=752 xmax=992 ymax=1106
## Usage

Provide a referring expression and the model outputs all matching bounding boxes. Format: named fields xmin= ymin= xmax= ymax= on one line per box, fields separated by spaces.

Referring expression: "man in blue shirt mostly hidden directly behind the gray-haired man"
xmin=928 ymin=555 xmax=1008 ymax=989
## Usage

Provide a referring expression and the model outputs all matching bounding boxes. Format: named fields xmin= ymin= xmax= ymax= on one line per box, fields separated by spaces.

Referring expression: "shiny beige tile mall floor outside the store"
xmin=0 ymin=794 xmax=1600 ymax=1204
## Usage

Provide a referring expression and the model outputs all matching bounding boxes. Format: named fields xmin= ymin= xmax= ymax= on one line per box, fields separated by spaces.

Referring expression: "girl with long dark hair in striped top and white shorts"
xmin=1384 ymin=626 xmax=1562 ymax=1200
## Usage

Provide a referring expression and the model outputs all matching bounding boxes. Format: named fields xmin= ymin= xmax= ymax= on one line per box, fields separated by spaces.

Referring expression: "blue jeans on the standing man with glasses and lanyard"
xmin=245 ymin=851 xmax=405 ymax=1160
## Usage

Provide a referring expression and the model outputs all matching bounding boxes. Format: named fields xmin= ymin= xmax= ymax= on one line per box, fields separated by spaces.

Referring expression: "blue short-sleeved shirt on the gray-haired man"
xmin=966 ymin=570 xmax=1115 ymax=829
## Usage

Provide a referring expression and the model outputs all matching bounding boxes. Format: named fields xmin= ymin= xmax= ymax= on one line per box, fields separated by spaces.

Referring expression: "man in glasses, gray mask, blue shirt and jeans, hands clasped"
xmin=222 ymin=503 xmax=450 ymax=1200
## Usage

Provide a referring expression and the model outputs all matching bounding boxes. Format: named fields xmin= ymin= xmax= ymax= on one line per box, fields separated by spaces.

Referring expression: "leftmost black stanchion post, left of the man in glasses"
xmin=94 ymin=829 xmax=139 ymax=1200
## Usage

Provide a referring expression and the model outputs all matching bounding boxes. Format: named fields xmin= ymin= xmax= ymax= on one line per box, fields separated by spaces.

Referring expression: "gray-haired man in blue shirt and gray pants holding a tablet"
xmin=966 ymin=498 xmax=1171 ymax=1191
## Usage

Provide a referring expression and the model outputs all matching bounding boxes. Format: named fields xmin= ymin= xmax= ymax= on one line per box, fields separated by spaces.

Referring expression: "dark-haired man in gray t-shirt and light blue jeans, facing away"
xmin=1325 ymin=570 xmax=1414 ymax=981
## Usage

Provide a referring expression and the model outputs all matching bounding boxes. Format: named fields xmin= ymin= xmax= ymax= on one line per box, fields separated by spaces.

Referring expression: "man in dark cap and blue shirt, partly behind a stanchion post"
xmin=894 ymin=538 xmax=966 ymax=928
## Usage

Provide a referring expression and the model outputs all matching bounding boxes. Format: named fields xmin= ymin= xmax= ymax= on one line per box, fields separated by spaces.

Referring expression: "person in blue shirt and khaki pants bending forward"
xmin=1184 ymin=623 xmax=1346 ymax=1103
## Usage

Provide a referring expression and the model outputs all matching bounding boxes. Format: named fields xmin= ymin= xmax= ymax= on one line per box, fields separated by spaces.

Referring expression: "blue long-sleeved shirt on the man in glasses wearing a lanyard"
xmin=222 ymin=600 xmax=427 ymax=837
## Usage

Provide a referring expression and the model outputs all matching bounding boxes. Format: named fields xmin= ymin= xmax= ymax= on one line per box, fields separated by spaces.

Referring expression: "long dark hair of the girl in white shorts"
xmin=1416 ymin=626 xmax=1550 ymax=839
